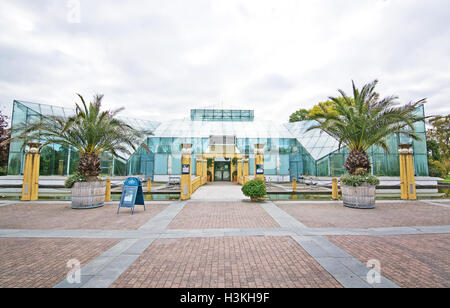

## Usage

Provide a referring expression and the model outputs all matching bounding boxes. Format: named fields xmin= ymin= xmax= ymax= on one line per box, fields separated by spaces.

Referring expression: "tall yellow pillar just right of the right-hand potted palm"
xmin=398 ymin=144 xmax=417 ymax=200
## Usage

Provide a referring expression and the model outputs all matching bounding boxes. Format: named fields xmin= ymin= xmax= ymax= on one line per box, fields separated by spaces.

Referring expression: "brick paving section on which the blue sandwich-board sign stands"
xmin=0 ymin=203 xmax=167 ymax=230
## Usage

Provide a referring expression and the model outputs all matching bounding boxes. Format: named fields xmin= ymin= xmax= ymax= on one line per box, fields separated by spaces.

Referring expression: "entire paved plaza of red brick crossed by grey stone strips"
xmin=0 ymin=184 xmax=450 ymax=288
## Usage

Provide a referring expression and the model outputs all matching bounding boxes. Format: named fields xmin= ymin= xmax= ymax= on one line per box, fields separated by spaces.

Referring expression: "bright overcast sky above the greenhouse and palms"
xmin=0 ymin=0 xmax=450 ymax=122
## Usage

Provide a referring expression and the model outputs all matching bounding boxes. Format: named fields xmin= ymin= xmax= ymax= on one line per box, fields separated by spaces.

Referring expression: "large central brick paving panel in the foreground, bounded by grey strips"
xmin=112 ymin=237 xmax=340 ymax=288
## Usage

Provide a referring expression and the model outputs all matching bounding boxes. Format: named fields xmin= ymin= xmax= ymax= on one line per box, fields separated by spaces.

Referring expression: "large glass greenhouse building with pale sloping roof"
xmin=8 ymin=101 xmax=428 ymax=181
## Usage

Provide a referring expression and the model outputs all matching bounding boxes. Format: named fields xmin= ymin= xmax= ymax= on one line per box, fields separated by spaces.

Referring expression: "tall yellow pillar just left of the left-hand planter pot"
xmin=21 ymin=143 xmax=41 ymax=201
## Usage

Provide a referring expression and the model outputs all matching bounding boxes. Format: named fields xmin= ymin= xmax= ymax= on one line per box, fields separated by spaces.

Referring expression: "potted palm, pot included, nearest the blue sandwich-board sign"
xmin=19 ymin=94 xmax=143 ymax=209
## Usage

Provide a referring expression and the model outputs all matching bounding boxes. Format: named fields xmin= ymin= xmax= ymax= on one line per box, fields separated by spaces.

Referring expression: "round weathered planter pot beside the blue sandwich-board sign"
xmin=72 ymin=181 xmax=106 ymax=209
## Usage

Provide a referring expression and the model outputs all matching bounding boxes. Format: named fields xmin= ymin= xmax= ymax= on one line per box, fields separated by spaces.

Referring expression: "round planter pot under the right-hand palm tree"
xmin=342 ymin=184 xmax=376 ymax=209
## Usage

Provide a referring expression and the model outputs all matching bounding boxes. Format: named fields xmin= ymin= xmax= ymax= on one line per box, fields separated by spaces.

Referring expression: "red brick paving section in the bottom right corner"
xmin=328 ymin=234 xmax=450 ymax=288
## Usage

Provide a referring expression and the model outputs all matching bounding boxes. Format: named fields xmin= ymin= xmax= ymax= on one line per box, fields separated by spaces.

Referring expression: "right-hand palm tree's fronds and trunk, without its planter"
xmin=309 ymin=80 xmax=426 ymax=175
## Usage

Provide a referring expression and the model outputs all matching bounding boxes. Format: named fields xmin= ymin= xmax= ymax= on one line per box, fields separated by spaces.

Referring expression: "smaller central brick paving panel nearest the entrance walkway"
xmin=169 ymin=202 xmax=279 ymax=229
